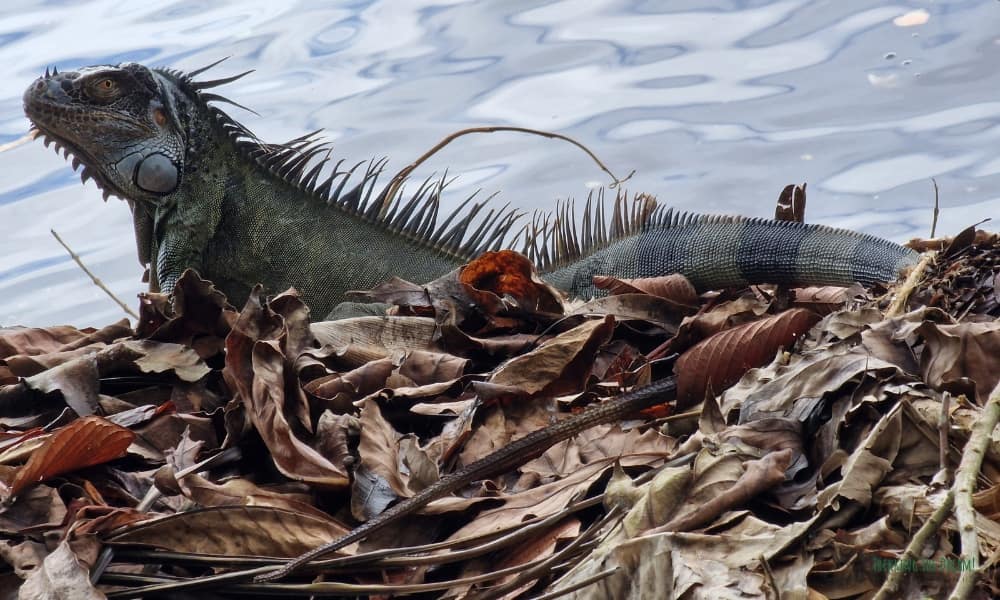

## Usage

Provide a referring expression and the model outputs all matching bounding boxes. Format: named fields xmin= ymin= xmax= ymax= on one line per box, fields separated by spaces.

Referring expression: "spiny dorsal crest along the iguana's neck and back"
xmin=158 ymin=59 xmax=688 ymax=270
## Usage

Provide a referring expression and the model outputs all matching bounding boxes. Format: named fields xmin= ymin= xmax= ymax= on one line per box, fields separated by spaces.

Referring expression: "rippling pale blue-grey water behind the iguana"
xmin=0 ymin=0 xmax=1000 ymax=325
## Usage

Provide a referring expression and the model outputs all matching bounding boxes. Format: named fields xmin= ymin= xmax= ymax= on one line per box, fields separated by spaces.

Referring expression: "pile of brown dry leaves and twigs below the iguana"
xmin=0 ymin=230 xmax=1000 ymax=599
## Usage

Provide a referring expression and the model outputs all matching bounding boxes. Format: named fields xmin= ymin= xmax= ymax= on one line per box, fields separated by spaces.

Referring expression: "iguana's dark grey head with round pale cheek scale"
xmin=24 ymin=63 xmax=190 ymax=202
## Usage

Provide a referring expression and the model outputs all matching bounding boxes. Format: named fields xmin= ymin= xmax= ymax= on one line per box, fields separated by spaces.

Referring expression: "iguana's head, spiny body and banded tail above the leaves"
xmin=24 ymin=61 xmax=917 ymax=315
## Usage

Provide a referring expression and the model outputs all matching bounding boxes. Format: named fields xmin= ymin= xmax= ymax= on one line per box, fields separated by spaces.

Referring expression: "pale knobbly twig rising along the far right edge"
xmin=949 ymin=383 xmax=1000 ymax=600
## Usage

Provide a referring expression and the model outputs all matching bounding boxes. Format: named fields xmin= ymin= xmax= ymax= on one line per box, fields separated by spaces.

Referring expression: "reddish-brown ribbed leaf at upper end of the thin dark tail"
xmin=674 ymin=308 xmax=819 ymax=409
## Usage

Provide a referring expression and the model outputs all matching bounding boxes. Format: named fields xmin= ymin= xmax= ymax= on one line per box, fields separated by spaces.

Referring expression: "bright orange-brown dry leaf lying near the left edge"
xmin=10 ymin=415 xmax=135 ymax=497
